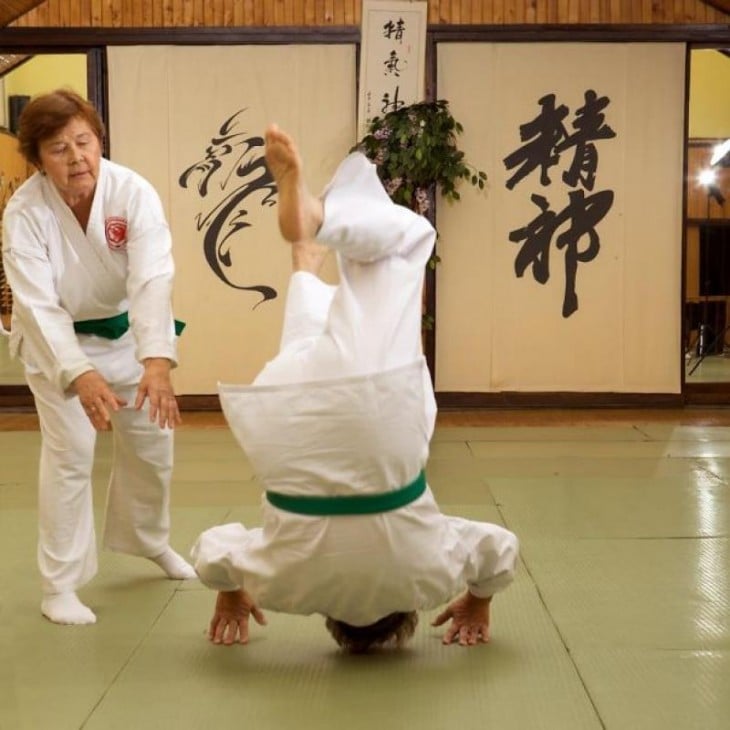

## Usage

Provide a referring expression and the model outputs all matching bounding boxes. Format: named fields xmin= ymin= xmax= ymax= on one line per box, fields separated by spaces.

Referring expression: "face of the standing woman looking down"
xmin=38 ymin=117 xmax=101 ymax=206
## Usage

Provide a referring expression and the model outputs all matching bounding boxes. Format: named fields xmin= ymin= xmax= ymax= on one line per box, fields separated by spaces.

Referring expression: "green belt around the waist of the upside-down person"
xmin=266 ymin=471 xmax=426 ymax=517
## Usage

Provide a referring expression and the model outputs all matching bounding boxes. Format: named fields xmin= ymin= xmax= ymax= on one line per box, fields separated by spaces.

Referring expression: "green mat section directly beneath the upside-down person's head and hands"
xmin=79 ymin=576 xmax=601 ymax=730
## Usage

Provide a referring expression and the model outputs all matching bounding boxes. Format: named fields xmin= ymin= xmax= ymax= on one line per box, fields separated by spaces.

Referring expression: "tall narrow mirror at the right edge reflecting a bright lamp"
xmin=684 ymin=49 xmax=730 ymax=384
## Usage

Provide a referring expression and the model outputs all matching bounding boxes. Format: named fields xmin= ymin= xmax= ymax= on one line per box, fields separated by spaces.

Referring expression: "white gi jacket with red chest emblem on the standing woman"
xmin=3 ymin=159 xmax=177 ymax=391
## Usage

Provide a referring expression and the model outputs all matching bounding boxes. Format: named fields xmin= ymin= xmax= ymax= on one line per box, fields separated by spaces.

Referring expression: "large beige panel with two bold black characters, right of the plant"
xmin=436 ymin=43 xmax=685 ymax=393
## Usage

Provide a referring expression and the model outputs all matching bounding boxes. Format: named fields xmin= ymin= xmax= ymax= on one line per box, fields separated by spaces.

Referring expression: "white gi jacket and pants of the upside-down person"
xmin=193 ymin=153 xmax=517 ymax=626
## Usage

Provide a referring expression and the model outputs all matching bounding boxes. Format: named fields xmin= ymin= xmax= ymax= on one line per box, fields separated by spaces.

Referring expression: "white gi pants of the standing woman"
xmin=26 ymin=372 xmax=173 ymax=593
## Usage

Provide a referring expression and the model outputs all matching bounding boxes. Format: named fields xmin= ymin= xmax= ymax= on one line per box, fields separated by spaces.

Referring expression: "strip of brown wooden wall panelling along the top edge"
xmin=12 ymin=0 xmax=730 ymax=28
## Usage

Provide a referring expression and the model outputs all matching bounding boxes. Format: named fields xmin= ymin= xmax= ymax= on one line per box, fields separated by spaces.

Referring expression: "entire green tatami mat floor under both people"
xmin=0 ymin=421 xmax=730 ymax=730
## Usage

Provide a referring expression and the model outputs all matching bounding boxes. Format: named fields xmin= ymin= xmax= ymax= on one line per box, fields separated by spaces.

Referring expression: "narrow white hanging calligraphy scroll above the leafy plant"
xmin=357 ymin=0 xmax=428 ymax=139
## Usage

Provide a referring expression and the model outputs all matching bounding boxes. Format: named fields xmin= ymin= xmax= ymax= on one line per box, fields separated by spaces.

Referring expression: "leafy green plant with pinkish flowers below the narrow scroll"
xmin=355 ymin=99 xmax=487 ymax=215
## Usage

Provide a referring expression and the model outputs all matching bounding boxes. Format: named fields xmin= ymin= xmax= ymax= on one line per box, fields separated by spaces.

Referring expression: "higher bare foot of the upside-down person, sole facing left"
xmin=265 ymin=124 xmax=323 ymax=243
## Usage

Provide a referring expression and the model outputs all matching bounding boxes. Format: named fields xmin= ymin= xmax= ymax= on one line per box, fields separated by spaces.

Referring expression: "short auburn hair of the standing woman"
xmin=18 ymin=89 xmax=104 ymax=167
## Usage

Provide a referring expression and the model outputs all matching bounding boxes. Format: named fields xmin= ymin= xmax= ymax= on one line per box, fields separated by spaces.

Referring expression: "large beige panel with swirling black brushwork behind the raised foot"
xmin=109 ymin=45 xmax=356 ymax=395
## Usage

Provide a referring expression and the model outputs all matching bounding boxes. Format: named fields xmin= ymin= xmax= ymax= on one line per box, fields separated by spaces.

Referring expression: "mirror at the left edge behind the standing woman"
xmin=0 ymin=53 xmax=88 ymax=387
